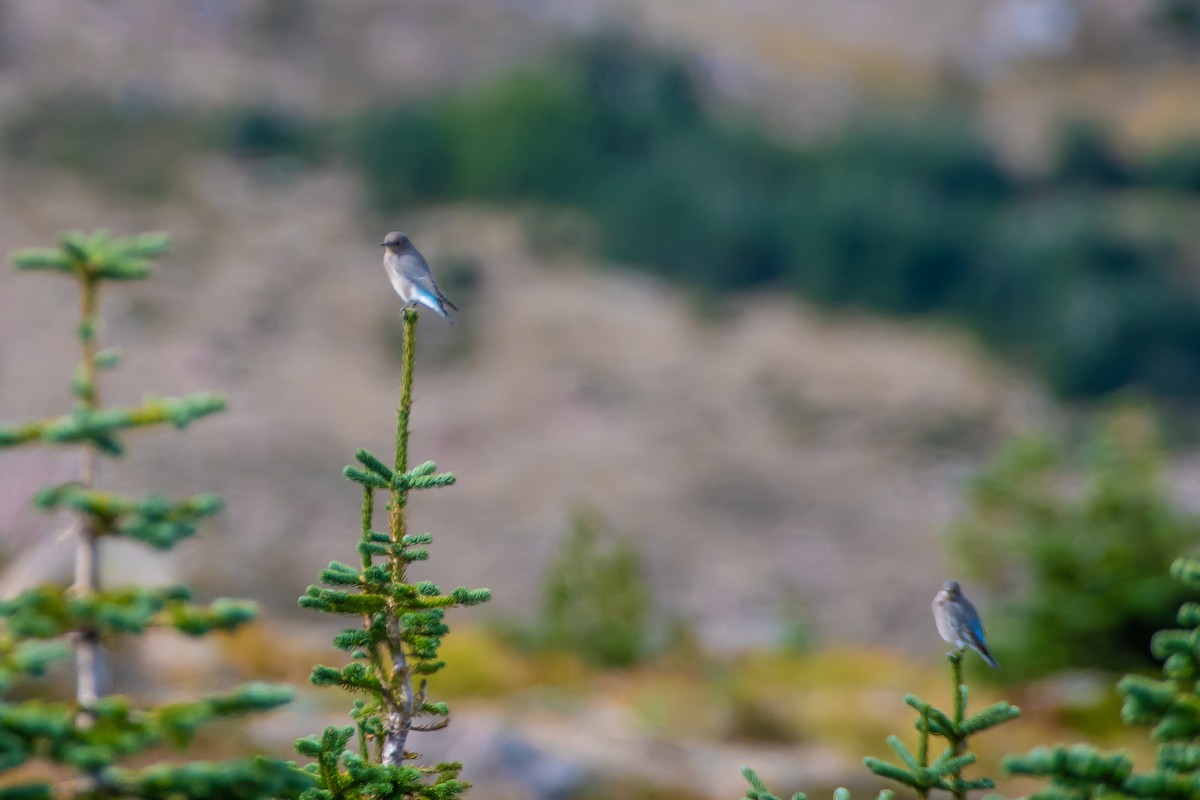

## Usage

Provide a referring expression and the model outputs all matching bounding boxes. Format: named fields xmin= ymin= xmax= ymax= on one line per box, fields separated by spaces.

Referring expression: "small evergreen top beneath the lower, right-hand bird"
xmin=742 ymin=651 xmax=1021 ymax=800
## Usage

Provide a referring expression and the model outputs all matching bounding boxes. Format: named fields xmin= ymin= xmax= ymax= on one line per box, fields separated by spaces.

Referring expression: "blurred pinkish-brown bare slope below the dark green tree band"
xmin=0 ymin=172 xmax=1031 ymax=643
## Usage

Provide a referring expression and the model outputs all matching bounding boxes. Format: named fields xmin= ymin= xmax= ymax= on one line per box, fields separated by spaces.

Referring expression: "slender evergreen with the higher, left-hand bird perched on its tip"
xmin=296 ymin=311 xmax=491 ymax=800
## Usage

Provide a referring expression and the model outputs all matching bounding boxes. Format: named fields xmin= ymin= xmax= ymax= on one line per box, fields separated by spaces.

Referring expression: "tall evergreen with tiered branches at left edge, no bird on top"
xmin=0 ymin=230 xmax=312 ymax=800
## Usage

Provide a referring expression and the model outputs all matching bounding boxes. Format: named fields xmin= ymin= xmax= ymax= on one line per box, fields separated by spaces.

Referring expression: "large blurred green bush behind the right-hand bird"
xmin=952 ymin=409 xmax=1200 ymax=679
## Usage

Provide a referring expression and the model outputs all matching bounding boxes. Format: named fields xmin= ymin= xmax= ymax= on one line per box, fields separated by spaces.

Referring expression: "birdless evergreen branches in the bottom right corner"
xmin=1004 ymin=559 xmax=1200 ymax=800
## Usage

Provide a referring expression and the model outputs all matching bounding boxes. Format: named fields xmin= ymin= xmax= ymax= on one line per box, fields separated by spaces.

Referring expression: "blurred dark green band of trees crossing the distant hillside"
xmin=9 ymin=34 xmax=1200 ymax=398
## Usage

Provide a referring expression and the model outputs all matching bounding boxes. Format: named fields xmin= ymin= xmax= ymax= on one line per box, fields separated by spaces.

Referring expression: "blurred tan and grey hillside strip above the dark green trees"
xmin=0 ymin=0 xmax=1200 ymax=146
